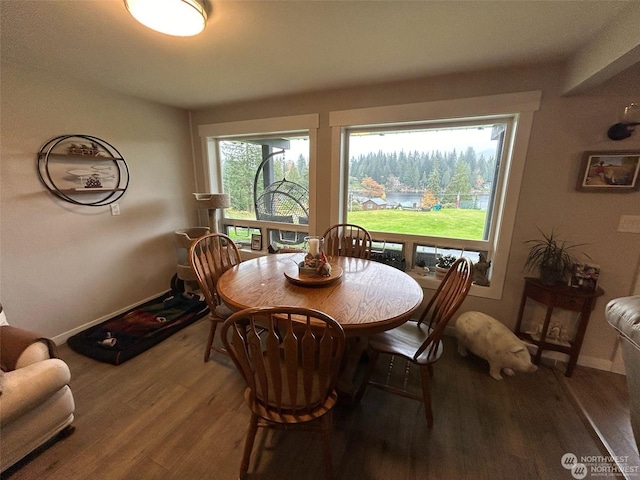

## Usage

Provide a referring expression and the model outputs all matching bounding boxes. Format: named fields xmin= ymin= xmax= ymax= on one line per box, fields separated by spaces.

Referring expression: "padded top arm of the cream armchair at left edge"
xmin=0 ymin=358 xmax=71 ymax=424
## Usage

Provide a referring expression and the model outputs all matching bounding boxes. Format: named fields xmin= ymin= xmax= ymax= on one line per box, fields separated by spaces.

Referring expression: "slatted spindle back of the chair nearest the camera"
xmin=222 ymin=307 xmax=345 ymax=418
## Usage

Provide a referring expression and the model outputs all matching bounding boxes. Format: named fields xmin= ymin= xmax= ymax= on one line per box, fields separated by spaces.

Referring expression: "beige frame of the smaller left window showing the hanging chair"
xmin=198 ymin=114 xmax=320 ymax=238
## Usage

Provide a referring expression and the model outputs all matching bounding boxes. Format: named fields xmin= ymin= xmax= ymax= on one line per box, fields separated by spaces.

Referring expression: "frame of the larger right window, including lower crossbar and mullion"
xmin=329 ymin=91 xmax=541 ymax=299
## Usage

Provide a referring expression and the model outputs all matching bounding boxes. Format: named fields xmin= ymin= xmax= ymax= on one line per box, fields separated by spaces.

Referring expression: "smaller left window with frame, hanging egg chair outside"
xmin=200 ymin=115 xmax=317 ymax=248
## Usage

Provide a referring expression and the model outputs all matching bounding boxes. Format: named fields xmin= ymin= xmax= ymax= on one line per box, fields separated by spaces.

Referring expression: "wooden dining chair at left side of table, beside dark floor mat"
xmin=189 ymin=233 xmax=242 ymax=362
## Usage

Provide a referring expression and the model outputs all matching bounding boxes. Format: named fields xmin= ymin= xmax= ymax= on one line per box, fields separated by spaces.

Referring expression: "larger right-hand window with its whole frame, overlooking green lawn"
xmin=330 ymin=92 xmax=540 ymax=298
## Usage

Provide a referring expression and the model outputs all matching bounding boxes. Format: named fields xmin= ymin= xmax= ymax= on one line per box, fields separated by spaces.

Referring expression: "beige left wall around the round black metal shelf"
xmin=0 ymin=64 xmax=196 ymax=342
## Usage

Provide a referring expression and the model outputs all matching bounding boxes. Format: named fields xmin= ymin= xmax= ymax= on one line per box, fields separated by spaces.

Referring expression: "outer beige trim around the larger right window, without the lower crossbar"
xmin=329 ymin=91 xmax=542 ymax=299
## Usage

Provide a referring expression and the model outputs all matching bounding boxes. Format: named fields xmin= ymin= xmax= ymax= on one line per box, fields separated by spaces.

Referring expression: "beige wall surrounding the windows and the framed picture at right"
xmin=193 ymin=65 xmax=640 ymax=369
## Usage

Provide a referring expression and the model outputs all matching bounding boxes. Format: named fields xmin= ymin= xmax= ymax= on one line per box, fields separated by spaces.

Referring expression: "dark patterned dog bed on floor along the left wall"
xmin=67 ymin=292 xmax=209 ymax=365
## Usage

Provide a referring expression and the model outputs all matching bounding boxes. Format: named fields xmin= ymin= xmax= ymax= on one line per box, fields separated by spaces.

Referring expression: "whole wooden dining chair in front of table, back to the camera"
xmin=222 ymin=307 xmax=345 ymax=479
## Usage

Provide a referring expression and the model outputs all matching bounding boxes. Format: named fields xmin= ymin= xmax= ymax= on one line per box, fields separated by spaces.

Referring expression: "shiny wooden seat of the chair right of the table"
xmin=369 ymin=321 xmax=443 ymax=365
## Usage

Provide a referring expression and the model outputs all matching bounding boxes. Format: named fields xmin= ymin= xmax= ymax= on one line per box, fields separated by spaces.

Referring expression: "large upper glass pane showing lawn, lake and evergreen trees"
xmin=346 ymin=119 xmax=511 ymax=240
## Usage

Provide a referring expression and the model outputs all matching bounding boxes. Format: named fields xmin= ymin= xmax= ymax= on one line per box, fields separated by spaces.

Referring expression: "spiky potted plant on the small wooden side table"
xmin=524 ymin=228 xmax=590 ymax=285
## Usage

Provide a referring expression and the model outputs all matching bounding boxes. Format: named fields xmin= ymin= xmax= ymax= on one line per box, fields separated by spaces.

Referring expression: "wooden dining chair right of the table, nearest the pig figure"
xmin=355 ymin=258 xmax=473 ymax=428
